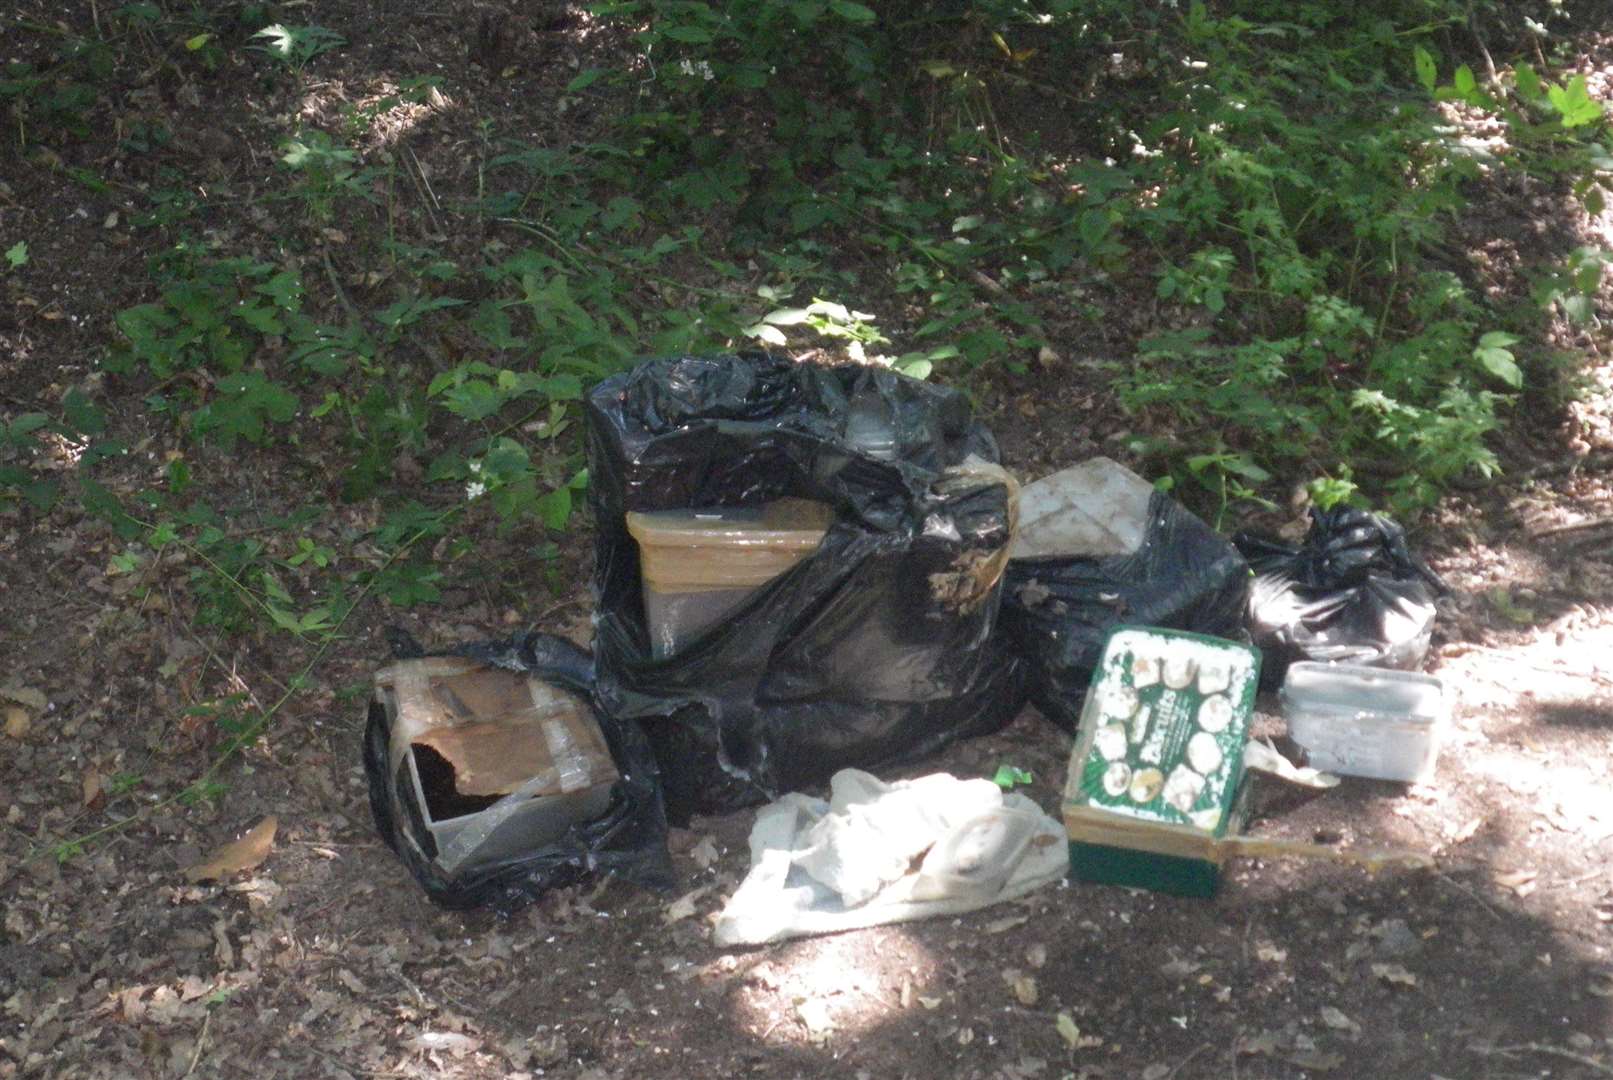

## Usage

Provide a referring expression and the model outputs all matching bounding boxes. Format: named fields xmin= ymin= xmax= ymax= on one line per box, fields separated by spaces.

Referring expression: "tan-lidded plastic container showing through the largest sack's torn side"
xmin=627 ymin=498 xmax=834 ymax=659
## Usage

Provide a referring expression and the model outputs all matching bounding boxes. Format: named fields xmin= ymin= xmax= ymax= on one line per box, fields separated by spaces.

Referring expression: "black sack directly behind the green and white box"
xmin=1002 ymin=492 xmax=1248 ymax=732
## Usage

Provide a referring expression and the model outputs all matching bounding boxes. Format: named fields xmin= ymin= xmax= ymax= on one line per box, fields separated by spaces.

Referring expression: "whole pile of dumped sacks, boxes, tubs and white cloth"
xmin=365 ymin=355 xmax=1448 ymax=945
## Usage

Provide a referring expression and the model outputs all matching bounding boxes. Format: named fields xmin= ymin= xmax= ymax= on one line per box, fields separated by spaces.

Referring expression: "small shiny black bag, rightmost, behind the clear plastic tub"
xmin=1232 ymin=506 xmax=1448 ymax=687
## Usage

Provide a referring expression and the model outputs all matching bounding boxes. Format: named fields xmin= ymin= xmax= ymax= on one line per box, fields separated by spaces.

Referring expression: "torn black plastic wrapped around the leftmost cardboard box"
xmin=363 ymin=630 xmax=674 ymax=916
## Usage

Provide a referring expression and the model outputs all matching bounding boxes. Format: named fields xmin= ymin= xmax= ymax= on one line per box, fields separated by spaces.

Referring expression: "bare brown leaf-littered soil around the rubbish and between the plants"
xmin=0 ymin=3 xmax=1613 ymax=1080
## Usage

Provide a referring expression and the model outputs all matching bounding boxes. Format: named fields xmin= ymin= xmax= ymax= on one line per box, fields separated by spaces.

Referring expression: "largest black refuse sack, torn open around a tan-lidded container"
xmin=587 ymin=355 xmax=1023 ymax=820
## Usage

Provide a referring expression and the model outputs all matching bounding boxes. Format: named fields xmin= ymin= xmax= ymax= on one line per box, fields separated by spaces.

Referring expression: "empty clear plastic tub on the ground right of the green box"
xmin=1281 ymin=661 xmax=1450 ymax=783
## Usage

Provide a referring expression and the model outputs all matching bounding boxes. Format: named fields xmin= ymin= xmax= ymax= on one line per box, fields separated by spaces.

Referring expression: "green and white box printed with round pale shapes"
xmin=1065 ymin=625 xmax=1260 ymax=896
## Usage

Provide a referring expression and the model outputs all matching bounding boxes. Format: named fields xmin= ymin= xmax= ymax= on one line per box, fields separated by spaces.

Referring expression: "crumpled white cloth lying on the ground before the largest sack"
xmin=713 ymin=769 xmax=1069 ymax=946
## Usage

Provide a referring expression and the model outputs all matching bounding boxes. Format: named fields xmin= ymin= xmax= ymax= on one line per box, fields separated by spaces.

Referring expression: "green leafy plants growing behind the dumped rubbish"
xmin=0 ymin=0 xmax=1613 ymax=857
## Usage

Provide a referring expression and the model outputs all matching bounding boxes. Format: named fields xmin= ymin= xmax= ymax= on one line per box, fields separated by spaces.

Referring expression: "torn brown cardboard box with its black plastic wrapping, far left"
xmin=365 ymin=633 xmax=671 ymax=912
